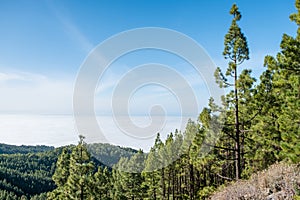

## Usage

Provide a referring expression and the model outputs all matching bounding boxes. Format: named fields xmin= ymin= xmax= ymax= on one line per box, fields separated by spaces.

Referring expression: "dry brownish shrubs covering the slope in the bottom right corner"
xmin=210 ymin=163 xmax=300 ymax=200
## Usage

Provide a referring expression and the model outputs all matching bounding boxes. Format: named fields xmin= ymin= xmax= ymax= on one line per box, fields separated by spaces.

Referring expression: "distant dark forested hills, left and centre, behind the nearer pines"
xmin=0 ymin=144 xmax=135 ymax=199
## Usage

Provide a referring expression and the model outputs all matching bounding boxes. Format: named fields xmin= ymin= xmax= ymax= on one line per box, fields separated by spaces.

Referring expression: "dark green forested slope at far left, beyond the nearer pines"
xmin=0 ymin=145 xmax=61 ymax=199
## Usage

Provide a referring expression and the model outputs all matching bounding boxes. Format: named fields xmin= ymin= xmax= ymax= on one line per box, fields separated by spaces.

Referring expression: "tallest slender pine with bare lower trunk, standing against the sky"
xmin=215 ymin=4 xmax=254 ymax=179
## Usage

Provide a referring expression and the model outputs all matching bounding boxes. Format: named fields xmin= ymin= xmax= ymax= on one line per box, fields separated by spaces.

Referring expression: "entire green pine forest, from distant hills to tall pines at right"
xmin=0 ymin=0 xmax=300 ymax=199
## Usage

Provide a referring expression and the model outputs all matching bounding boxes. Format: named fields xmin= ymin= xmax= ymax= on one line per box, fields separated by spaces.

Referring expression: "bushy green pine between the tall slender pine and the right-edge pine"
xmin=245 ymin=59 xmax=282 ymax=175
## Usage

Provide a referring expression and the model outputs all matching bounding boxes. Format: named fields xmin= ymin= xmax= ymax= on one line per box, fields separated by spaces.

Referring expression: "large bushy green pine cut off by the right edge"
xmin=265 ymin=0 xmax=300 ymax=162
